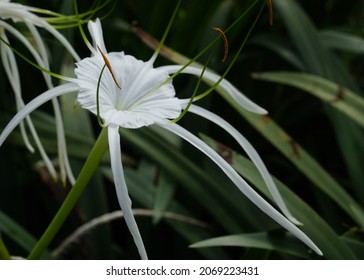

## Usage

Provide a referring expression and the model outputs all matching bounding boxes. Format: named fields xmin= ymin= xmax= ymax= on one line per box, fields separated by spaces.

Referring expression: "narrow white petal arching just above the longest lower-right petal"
xmin=188 ymin=105 xmax=301 ymax=224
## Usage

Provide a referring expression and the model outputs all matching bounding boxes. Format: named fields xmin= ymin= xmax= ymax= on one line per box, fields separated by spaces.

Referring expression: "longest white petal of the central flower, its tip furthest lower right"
xmin=158 ymin=123 xmax=322 ymax=255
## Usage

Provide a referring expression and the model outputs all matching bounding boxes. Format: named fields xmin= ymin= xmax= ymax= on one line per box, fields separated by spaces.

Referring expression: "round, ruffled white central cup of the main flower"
xmin=75 ymin=52 xmax=181 ymax=128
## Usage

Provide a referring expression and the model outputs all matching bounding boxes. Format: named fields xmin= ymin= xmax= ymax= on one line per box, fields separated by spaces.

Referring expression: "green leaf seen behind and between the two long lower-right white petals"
xmin=203 ymin=136 xmax=356 ymax=259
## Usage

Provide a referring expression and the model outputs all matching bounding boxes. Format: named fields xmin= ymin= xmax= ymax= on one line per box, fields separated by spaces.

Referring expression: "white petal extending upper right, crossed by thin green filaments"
xmin=157 ymin=65 xmax=267 ymax=115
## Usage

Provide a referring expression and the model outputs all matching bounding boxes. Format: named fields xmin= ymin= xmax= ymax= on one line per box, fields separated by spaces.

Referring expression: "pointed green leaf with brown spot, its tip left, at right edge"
xmin=253 ymin=72 xmax=364 ymax=127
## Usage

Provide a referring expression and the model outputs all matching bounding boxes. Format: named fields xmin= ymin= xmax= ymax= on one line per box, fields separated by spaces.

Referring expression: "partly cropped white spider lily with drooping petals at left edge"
xmin=0 ymin=0 xmax=80 ymax=184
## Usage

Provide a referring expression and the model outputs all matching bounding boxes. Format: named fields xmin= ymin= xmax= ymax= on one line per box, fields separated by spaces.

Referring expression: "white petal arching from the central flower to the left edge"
xmin=0 ymin=83 xmax=79 ymax=146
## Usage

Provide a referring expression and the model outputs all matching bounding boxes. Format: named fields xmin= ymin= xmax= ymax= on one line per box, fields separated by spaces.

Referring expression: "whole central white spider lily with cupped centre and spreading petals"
xmin=0 ymin=20 xmax=322 ymax=259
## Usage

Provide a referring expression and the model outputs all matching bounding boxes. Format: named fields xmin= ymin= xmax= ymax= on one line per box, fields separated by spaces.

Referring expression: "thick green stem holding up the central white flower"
xmin=28 ymin=128 xmax=108 ymax=260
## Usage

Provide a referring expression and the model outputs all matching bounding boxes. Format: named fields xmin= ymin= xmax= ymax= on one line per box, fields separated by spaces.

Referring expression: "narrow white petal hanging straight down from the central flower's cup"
xmin=107 ymin=124 xmax=148 ymax=260
